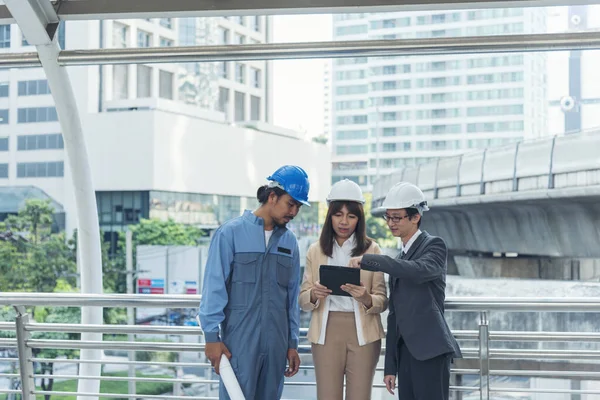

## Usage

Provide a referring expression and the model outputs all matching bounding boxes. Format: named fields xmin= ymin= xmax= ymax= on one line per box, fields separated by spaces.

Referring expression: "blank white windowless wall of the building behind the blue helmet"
xmin=85 ymin=110 xmax=331 ymax=201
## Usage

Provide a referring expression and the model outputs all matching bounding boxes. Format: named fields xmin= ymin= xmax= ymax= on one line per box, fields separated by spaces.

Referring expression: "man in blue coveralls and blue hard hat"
xmin=199 ymin=165 xmax=309 ymax=400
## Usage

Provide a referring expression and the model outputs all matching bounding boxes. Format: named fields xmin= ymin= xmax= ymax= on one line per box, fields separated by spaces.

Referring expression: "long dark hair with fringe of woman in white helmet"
xmin=319 ymin=201 xmax=373 ymax=257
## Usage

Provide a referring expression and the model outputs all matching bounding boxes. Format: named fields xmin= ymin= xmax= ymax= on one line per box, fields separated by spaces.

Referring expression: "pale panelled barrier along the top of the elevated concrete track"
xmin=372 ymin=128 xmax=600 ymax=209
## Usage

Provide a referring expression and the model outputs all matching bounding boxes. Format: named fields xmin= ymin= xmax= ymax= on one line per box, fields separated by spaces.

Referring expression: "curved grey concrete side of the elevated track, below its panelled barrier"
xmin=423 ymin=195 xmax=600 ymax=258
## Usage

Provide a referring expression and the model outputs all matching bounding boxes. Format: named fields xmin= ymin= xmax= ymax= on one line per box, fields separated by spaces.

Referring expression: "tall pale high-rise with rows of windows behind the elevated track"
xmin=332 ymin=8 xmax=547 ymax=189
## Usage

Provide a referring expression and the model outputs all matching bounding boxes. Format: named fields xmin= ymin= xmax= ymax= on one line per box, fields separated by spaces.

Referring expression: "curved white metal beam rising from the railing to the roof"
xmin=5 ymin=0 xmax=103 ymax=400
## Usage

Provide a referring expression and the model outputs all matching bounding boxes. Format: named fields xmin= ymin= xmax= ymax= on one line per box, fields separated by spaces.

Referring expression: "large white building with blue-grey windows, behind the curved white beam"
xmin=0 ymin=17 xmax=330 ymax=244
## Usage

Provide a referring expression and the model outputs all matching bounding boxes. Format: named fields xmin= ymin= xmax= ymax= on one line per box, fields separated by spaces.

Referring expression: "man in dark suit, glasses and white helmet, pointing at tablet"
xmin=350 ymin=182 xmax=462 ymax=400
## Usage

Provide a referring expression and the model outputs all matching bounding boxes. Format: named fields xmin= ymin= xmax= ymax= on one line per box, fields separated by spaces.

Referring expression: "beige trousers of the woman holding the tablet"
xmin=312 ymin=312 xmax=381 ymax=400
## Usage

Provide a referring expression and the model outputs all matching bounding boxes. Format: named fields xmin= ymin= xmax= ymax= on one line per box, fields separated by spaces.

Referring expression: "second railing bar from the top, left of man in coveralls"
xmin=25 ymin=323 xmax=202 ymax=335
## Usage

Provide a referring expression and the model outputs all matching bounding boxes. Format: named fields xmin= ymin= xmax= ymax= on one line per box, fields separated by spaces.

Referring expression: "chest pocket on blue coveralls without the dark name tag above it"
xmin=227 ymin=253 xmax=258 ymax=309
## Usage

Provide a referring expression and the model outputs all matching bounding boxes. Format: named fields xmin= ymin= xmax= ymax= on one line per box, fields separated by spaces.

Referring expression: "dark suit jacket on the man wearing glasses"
xmin=361 ymin=232 xmax=462 ymax=375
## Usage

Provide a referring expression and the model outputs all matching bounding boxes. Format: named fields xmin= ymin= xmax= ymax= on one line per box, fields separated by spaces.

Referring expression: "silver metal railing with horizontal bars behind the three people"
xmin=0 ymin=293 xmax=600 ymax=400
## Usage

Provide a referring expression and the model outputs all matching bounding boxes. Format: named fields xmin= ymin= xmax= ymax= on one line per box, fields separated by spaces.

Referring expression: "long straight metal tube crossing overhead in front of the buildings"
xmin=0 ymin=32 xmax=600 ymax=68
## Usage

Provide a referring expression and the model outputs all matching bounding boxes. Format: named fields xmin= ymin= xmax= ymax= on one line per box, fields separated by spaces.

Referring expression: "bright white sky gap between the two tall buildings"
xmin=273 ymin=15 xmax=332 ymax=141
